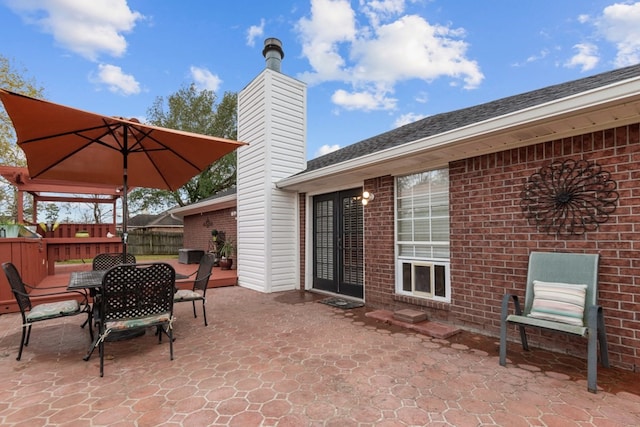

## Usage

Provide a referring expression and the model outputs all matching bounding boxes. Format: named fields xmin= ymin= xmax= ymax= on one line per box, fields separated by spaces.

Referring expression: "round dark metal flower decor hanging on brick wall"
xmin=520 ymin=160 xmax=619 ymax=235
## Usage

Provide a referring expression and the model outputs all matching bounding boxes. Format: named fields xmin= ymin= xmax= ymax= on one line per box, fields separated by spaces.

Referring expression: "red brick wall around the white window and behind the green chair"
xmin=364 ymin=124 xmax=640 ymax=371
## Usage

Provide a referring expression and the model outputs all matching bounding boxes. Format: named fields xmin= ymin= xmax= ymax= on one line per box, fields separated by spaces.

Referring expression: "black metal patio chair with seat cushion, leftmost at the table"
xmin=2 ymin=262 xmax=93 ymax=360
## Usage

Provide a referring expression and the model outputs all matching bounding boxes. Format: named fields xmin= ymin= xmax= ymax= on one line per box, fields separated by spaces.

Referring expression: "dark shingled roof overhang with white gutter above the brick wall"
xmin=278 ymin=64 xmax=640 ymax=191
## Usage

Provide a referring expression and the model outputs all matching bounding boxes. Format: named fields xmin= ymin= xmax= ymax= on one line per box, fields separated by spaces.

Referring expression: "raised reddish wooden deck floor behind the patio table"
xmin=31 ymin=259 xmax=238 ymax=297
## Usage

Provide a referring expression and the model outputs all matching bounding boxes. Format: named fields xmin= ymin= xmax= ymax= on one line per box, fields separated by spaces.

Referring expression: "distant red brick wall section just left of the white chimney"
xmin=183 ymin=208 xmax=238 ymax=251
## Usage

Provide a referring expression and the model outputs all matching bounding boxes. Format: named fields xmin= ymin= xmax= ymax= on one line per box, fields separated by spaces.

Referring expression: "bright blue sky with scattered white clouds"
xmin=0 ymin=0 xmax=640 ymax=159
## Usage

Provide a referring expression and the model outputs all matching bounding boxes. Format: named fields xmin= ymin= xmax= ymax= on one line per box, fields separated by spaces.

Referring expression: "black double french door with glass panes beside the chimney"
xmin=313 ymin=188 xmax=364 ymax=298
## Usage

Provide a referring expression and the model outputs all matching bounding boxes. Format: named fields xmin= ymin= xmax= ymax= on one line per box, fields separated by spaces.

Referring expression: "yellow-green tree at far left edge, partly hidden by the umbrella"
xmin=0 ymin=55 xmax=43 ymax=222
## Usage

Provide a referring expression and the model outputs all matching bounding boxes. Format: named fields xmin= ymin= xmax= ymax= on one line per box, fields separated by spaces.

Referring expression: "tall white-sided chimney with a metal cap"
xmin=236 ymin=39 xmax=307 ymax=292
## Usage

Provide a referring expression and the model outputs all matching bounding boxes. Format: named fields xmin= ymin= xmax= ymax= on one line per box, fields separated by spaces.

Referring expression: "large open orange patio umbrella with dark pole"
xmin=0 ymin=89 xmax=245 ymax=252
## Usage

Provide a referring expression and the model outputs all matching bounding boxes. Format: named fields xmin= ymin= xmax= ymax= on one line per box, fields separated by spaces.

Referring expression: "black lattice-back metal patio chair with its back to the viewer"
xmin=85 ymin=262 xmax=175 ymax=377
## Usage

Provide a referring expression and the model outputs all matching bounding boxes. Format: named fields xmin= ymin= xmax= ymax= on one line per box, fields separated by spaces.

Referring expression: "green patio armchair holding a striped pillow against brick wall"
xmin=500 ymin=252 xmax=609 ymax=393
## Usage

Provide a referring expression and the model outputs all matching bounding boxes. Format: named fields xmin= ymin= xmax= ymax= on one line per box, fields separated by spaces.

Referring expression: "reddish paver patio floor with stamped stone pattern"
xmin=0 ymin=286 xmax=640 ymax=427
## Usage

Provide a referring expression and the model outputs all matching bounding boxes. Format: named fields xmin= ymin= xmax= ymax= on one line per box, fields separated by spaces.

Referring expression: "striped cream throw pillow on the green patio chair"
xmin=529 ymin=280 xmax=587 ymax=326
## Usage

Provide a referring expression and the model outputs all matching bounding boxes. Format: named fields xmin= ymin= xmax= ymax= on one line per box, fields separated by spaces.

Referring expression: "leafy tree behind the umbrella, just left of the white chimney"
xmin=129 ymin=84 xmax=238 ymax=212
